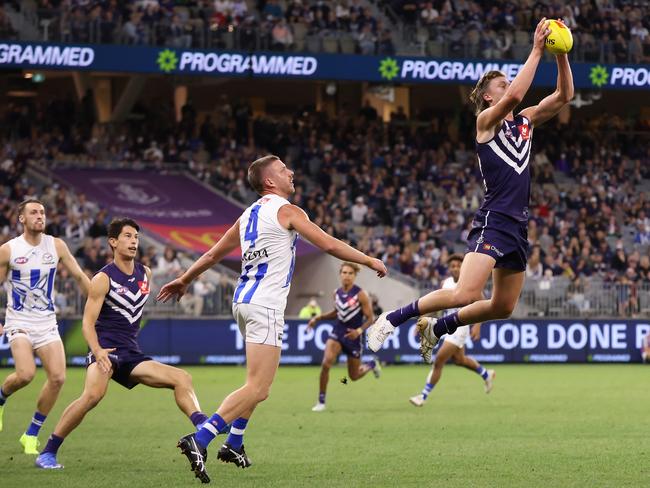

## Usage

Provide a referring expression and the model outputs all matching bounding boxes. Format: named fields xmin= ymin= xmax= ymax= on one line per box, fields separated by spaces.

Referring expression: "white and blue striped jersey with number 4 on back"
xmin=233 ymin=194 xmax=298 ymax=313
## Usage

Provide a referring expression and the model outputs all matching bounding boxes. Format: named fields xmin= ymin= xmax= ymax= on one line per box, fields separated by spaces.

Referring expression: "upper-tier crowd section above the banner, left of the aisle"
xmin=12 ymin=0 xmax=394 ymax=54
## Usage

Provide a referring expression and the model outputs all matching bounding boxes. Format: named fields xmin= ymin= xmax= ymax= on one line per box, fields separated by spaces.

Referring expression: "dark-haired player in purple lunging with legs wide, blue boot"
xmin=36 ymin=218 xmax=208 ymax=469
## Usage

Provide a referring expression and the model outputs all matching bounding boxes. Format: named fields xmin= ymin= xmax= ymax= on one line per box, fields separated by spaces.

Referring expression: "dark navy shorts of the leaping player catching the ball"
xmin=467 ymin=211 xmax=529 ymax=271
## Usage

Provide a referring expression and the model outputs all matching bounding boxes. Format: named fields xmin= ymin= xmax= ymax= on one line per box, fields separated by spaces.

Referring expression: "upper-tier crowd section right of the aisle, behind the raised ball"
xmin=381 ymin=0 xmax=650 ymax=63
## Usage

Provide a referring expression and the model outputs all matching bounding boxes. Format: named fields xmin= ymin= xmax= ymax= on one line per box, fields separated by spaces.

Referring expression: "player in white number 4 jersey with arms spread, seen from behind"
xmin=158 ymin=155 xmax=386 ymax=483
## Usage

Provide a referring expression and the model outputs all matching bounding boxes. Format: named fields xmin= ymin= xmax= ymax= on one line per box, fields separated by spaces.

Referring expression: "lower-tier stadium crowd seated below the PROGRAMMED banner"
xmin=0 ymin=93 xmax=650 ymax=316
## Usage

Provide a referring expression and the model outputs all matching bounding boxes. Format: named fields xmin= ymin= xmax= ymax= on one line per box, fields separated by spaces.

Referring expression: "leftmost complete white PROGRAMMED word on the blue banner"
xmin=172 ymin=51 xmax=318 ymax=76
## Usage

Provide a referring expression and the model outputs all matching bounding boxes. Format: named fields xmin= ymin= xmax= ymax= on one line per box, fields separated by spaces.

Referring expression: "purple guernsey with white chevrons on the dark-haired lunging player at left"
xmin=96 ymin=263 xmax=150 ymax=350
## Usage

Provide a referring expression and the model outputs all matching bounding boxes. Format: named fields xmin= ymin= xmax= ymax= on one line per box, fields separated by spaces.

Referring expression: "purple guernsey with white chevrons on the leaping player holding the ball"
xmin=476 ymin=114 xmax=533 ymax=222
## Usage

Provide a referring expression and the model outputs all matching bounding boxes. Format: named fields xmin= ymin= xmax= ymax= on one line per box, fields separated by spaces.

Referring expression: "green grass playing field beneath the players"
xmin=0 ymin=365 xmax=650 ymax=488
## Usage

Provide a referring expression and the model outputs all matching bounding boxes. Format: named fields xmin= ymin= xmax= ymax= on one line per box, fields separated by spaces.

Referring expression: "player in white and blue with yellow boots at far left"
xmin=0 ymin=199 xmax=90 ymax=454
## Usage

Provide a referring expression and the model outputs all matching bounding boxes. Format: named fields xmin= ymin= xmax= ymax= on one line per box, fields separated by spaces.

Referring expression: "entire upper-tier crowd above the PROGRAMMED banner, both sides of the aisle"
xmin=0 ymin=0 xmax=650 ymax=63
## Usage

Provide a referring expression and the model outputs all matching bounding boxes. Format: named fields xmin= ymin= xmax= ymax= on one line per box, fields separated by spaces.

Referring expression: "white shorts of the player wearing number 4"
xmin=232 ymin=303 xmax=284 ymax=347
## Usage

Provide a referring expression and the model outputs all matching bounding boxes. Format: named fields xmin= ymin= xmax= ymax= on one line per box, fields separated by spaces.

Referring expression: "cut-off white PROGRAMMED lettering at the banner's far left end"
xmin=0 ymin=43 xmax=95 ymax=68
